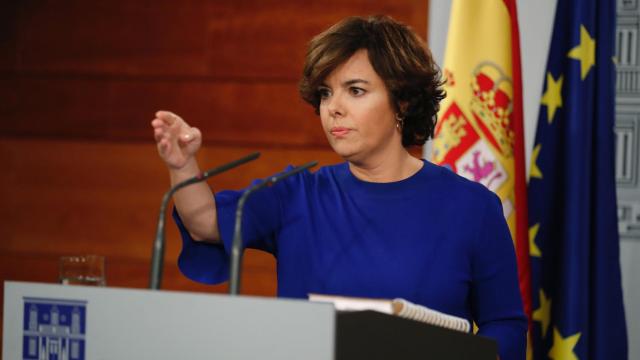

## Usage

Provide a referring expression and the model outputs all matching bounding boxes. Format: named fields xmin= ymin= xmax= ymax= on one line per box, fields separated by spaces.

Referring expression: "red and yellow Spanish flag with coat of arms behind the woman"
xmin=432 ymin=0 xmax=531 ymax=324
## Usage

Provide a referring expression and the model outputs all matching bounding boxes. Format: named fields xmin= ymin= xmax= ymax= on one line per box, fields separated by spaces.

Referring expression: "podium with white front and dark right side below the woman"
xmin=2 ymin=281 xmax=497 ymax=360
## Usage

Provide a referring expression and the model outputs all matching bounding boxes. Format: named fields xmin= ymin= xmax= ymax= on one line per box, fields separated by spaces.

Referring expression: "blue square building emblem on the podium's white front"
xmin=22 ymin=297 xmax=87 ymax=360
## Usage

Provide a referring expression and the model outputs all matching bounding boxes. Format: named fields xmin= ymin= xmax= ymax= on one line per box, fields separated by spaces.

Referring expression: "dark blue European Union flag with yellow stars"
xmin=529 ymin=0 xmax=627 ymax=359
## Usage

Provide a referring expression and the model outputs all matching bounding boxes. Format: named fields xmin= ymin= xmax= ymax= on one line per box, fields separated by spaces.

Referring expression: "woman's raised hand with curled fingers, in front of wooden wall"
xmin=151 ymin=111 xmax=202 ymax=170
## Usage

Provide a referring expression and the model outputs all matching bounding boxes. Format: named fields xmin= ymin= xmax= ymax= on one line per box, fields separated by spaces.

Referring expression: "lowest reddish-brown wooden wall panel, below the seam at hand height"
xmin=0 ymin=138 xmax=340 ymax=338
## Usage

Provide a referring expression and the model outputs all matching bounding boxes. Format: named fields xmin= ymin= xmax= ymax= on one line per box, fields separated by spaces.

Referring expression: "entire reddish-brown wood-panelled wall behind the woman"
xmin=0 ymin=0 xmax=428 ymax=344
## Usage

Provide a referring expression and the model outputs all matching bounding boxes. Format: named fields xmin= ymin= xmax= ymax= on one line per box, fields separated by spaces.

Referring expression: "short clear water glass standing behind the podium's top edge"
xmin=59 ymin=255 xmax=107 ymax=286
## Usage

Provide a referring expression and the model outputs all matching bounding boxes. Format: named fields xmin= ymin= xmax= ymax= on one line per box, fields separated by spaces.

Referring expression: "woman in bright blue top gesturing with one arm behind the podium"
xmin=152 ymin=17 xmax=527 ymax=359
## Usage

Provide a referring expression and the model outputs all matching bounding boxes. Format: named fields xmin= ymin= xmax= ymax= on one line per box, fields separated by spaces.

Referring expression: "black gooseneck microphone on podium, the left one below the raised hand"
xmin=149 ymin=152 xmax=260 ymax=290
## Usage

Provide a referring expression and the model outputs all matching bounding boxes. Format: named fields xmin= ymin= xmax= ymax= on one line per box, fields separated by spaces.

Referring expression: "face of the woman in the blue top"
xmin=319 ymin=50 xmax=403 ymax=163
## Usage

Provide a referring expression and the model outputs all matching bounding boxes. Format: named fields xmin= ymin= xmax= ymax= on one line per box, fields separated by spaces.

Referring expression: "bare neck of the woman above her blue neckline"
xmin=349 ymin=148 xmax=424 ymax=183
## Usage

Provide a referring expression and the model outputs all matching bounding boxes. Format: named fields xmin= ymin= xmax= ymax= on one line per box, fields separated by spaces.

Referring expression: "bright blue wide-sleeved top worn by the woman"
xmin=174 ymin=161 xmax=527 ymax=360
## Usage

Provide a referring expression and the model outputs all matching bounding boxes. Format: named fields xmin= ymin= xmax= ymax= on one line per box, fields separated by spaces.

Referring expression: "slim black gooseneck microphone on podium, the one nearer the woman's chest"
xmin=229 ymin=161 xmax=318 ymax=295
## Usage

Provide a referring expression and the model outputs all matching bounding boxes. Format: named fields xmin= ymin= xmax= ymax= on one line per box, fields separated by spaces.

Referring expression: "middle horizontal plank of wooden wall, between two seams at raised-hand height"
xmin=0 ymin=77 xmax=327 ymax=148
